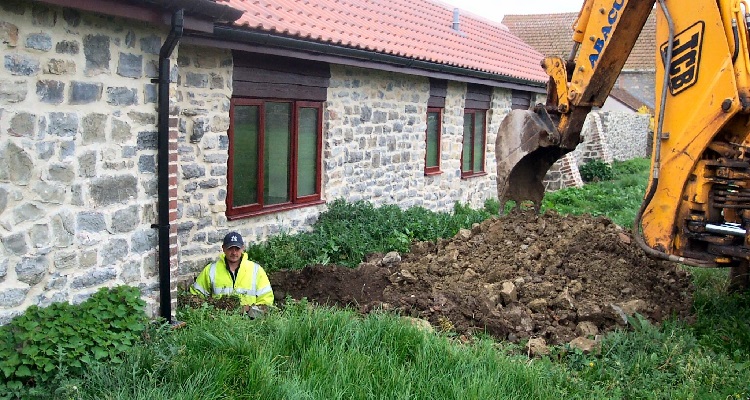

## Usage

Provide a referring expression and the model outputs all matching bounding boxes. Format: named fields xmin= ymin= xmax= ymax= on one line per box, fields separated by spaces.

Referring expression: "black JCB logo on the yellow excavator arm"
xmin=661 ymin=21 xmax=705 ymax=96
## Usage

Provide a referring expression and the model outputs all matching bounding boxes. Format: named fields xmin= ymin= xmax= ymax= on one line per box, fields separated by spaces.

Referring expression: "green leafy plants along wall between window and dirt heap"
xmin=247 ymin=199 xmax=500 ymax=272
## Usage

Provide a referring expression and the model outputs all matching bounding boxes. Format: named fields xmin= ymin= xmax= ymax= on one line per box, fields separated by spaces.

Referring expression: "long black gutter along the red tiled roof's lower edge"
xmin=213 ymin=26 xmax=547 ymax=87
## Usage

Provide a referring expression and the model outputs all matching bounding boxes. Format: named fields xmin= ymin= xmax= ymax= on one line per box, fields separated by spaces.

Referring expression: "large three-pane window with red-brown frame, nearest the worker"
xmin=227 ymin=98 xmax=323 ymax=218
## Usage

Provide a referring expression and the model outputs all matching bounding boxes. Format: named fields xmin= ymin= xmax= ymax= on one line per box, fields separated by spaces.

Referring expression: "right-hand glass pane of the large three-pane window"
xmin=297 ymin=108 xmax=318 ymax=196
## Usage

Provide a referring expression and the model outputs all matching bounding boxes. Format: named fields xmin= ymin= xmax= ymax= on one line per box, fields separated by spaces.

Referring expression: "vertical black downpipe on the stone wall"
xmin=152 ymin=9 xmax=184 ymax=324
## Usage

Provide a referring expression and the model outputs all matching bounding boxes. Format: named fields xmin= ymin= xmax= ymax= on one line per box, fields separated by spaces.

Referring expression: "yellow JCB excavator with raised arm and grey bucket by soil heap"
xmin=496 ymin=0 xmax=750 ymax=291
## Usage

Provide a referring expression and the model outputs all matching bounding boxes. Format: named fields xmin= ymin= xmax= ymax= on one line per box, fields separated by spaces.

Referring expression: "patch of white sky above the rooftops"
xmin=441 ymin=0 xmax=584 ymax=22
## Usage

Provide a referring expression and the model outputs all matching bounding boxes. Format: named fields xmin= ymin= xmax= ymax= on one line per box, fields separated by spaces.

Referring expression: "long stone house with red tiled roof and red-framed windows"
xmin=0 ymin=0 xmax=546 ymax=323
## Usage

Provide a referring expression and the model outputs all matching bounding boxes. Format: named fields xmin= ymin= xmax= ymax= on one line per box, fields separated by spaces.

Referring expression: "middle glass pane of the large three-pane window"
xmin=263 ymin=103 xmax=291 ymax=205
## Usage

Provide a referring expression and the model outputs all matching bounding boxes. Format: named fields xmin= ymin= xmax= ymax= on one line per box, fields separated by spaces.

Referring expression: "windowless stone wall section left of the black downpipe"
xmin=0 ymin=1 xmax=166 ymax=324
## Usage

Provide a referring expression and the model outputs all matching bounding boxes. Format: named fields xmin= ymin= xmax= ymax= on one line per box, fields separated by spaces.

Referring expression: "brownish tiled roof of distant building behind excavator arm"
xmin=503 ymin=12 xmax=656 ymax=71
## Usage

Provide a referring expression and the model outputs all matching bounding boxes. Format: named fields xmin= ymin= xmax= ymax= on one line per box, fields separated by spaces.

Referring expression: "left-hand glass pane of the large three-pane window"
xmin=232 ymin=106 xmax=259 ymax=207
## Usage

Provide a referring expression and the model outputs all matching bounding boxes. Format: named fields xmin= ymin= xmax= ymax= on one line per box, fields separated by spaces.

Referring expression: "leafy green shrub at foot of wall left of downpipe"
xmin=0 ymin=286 xmax=147 ymax=398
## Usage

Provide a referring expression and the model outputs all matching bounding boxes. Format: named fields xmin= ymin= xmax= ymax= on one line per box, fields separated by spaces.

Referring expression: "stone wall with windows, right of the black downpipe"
xmin=177 ymin=65 xmax=511 ymax=282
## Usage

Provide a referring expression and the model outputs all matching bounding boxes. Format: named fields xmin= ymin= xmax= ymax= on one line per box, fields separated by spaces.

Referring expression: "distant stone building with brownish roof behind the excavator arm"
xmin=502 ymin=12 xmax=656 ymax=190
